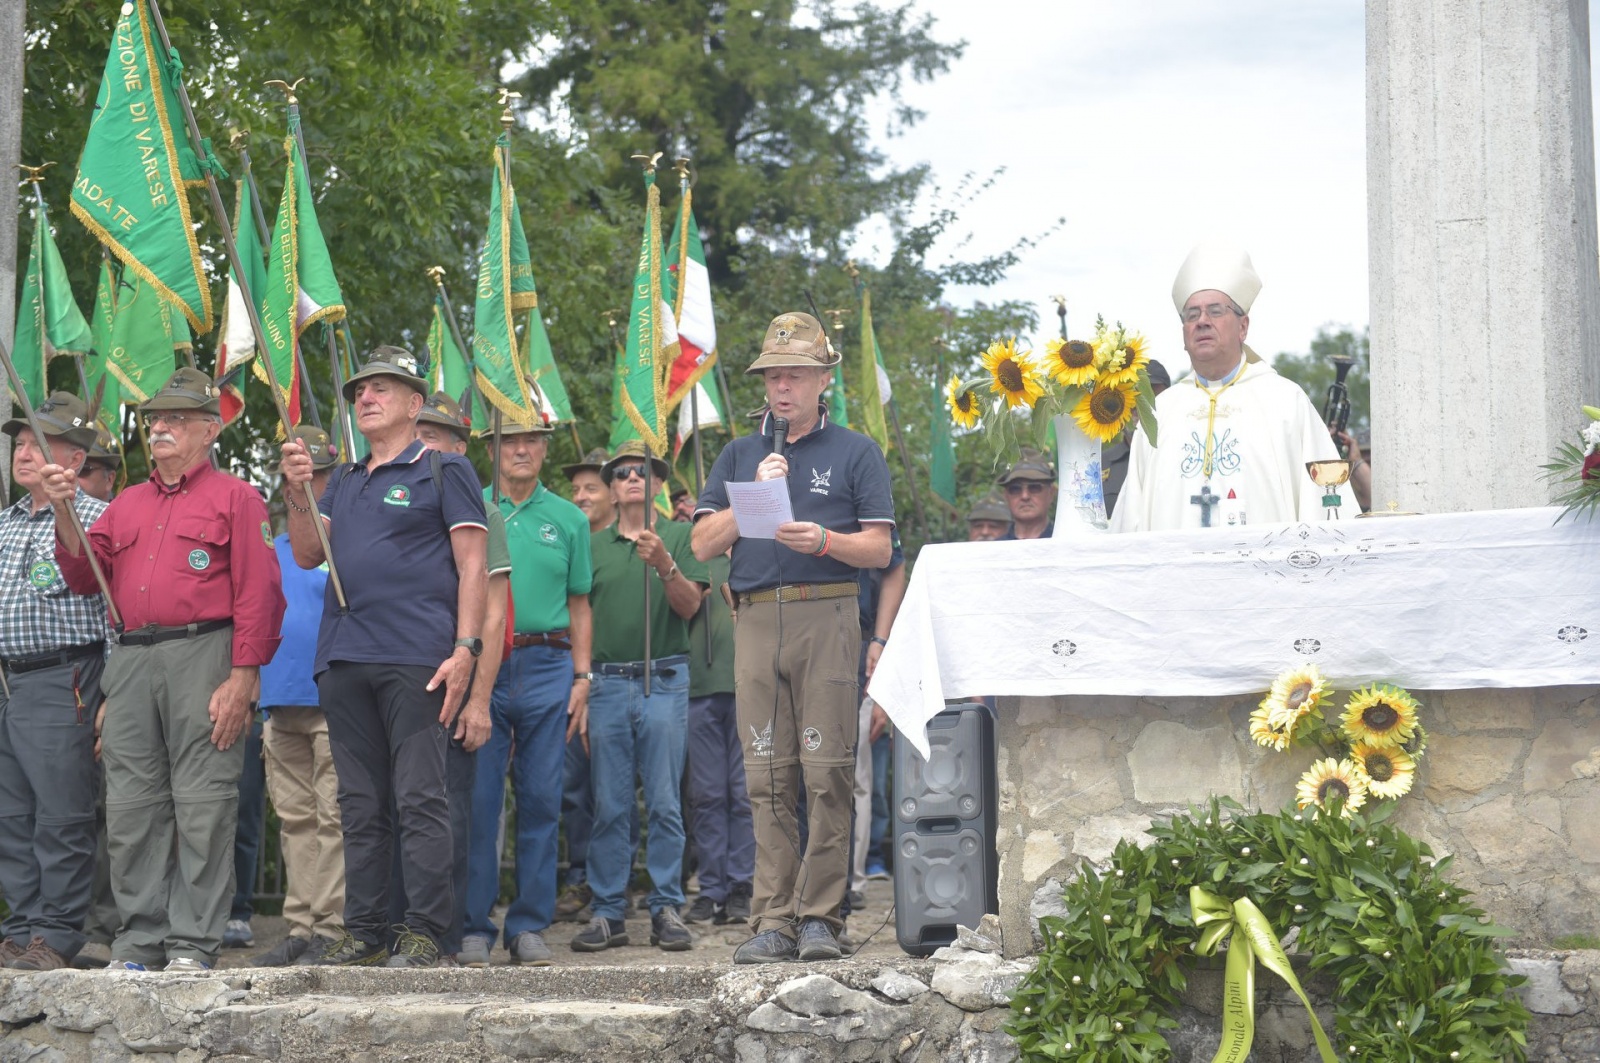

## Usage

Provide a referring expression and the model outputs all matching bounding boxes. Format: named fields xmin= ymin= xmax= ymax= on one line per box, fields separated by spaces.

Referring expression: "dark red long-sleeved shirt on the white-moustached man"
xmin=56 ymin=464 xmax=283 ymax=666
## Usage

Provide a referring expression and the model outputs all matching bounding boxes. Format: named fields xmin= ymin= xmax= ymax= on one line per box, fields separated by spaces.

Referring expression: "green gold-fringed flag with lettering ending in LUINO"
xmin=257 ymin=116 xmax=344 ymax=424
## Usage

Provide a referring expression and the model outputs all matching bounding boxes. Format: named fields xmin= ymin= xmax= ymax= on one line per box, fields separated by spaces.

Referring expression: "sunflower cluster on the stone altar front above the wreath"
xmin=1250 ymin=664 xmax=1427 ymax=816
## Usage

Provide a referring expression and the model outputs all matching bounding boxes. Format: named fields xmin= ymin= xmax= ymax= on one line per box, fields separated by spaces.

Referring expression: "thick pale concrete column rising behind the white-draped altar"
xmin=1366 ymin=0 xmax=1600 ymax=512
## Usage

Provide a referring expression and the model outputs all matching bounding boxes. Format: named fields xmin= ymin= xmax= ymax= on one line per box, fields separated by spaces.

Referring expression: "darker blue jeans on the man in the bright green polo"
xmin=466 ymin=645 xmax=573 ymax=945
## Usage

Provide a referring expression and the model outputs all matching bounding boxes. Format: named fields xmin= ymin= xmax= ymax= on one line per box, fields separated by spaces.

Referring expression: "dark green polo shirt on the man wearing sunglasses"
xmin=592 ymin=506 xmax=710 ymax=664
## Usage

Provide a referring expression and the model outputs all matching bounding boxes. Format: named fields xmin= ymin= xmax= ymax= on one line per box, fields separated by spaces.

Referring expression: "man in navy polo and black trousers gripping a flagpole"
xmin=283 ymin=346 xmax=488 ymax=967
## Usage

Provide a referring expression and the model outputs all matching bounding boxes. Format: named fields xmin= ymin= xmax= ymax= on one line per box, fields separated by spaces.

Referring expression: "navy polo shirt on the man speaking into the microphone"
xmin=694 ymin=410 xmax=894 ymax=594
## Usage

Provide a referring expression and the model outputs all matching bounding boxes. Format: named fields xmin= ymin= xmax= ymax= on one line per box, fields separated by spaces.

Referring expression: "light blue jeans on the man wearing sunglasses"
xmin=589 ymin=656 xmax=690 ymax=919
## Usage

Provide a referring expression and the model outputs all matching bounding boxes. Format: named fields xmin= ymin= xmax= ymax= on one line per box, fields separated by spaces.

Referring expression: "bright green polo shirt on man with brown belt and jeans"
xmin=483 ymin=483 xmax=594 ymax=636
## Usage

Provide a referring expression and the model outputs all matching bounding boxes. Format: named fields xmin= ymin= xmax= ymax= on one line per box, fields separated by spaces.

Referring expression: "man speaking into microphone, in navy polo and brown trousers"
xmin=693 ymin=314 xmax=894 ymax=964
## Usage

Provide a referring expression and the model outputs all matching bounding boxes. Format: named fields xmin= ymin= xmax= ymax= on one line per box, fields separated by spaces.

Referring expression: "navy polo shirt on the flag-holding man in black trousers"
xmin=315 ymin=442 xmax=488 ymax=676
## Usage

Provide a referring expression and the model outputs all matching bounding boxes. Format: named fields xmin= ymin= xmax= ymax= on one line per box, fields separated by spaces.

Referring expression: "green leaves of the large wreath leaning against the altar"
xmin=1006 ymin=799 xmax=1530 ymax=1063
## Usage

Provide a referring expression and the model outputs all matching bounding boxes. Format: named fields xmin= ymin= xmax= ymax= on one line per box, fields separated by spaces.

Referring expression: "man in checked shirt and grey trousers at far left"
xmin=0 ymin=391 xmax=106 ymax=970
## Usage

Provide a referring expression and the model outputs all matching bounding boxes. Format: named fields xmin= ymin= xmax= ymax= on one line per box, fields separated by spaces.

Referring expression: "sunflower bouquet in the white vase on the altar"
xmin=944 ymin=319 xmax=1155 ymax=459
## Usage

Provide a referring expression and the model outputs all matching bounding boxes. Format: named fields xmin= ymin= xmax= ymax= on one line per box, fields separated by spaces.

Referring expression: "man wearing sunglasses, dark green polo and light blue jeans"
xmin=573 ymin=440 xmax=710 ymax=953
